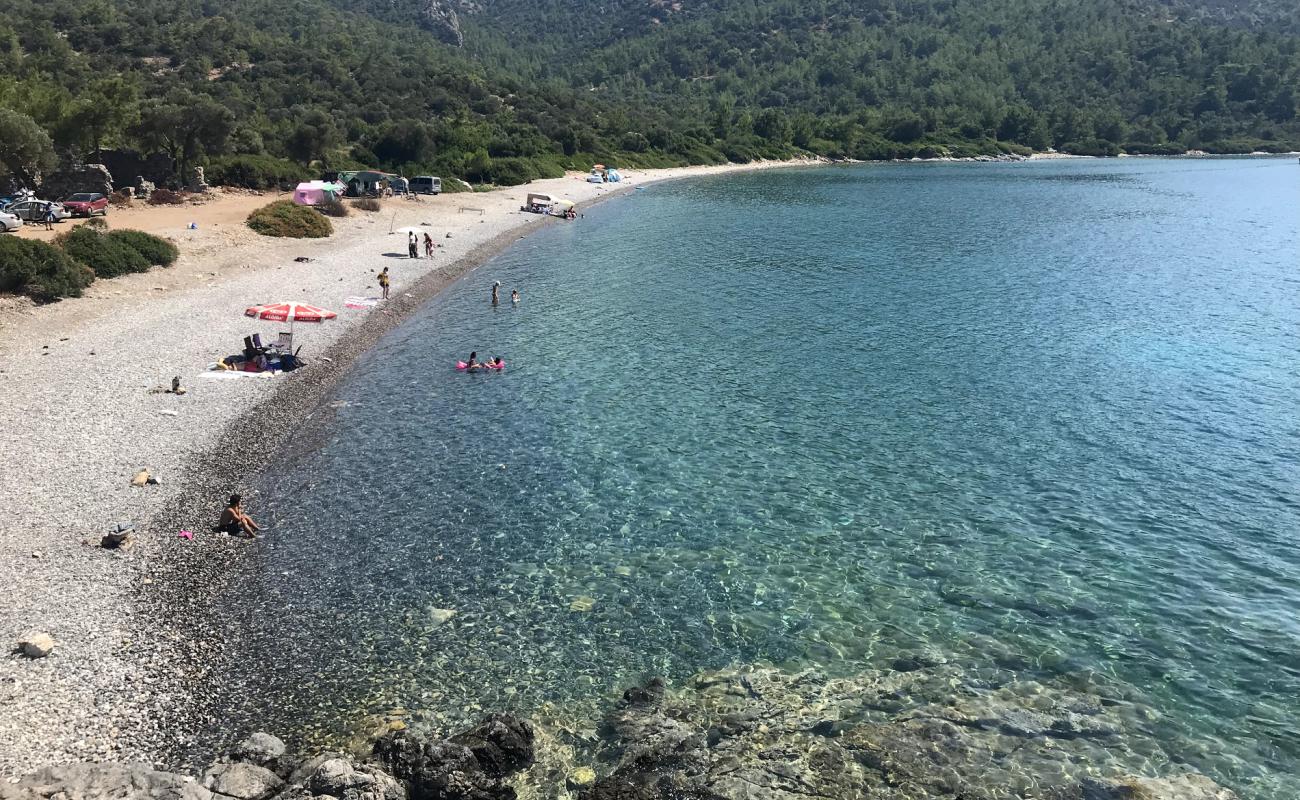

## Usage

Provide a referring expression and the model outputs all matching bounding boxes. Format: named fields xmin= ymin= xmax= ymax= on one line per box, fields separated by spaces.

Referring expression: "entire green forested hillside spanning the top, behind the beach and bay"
xmin=0 ymin=0 xmax=1300 ymax=191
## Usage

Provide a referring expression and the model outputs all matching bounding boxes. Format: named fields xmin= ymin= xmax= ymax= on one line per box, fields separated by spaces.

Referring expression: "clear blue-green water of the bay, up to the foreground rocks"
xmin=210 ymin=160 xmax=1300 ymax=799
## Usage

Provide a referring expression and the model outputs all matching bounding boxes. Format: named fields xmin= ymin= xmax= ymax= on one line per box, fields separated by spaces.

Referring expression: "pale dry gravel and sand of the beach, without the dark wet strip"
xmin=0 ymin=156 xmax=816 ymax=774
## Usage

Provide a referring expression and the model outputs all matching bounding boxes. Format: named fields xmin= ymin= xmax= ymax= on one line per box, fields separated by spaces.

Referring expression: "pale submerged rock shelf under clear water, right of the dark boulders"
xmin=579 ymin=662 xmax=1235 ymax=800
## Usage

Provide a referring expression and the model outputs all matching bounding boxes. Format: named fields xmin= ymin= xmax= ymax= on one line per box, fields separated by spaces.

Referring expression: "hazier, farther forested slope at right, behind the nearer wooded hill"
xmin=464 ymin=0 xmax=1300 ymax=157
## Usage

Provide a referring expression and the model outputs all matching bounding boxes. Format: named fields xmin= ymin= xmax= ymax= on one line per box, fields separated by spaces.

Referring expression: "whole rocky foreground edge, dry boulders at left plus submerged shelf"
xmin=0 ymin=660 xmax=1238 ymax=800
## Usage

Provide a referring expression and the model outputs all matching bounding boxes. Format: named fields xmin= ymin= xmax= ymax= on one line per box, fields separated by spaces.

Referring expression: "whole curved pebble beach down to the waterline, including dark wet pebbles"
xmin=0 ymin=159 xmax=811 ymax=777
